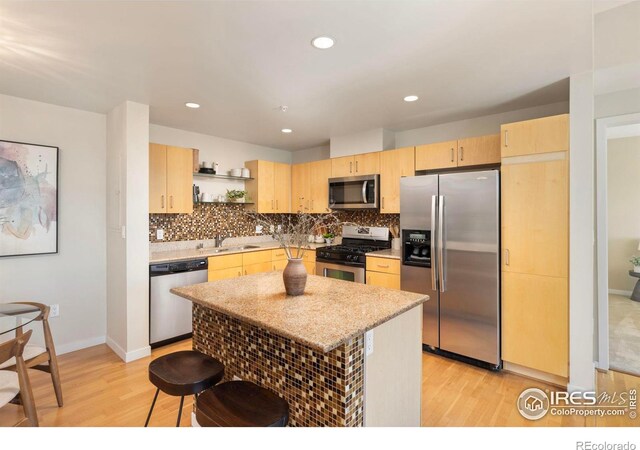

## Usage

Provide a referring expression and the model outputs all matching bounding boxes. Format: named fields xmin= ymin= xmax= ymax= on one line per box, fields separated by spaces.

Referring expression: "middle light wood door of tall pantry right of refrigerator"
xmin=501 ymin=160 xmax=569 ymax=277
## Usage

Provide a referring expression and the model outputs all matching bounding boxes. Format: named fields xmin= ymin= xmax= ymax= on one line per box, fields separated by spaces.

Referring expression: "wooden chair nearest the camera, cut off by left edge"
xmin=0 ymin=330 xmax=38 ymax=427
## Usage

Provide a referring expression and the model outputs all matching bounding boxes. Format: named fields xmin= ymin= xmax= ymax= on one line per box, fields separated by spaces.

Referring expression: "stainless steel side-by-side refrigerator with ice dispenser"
xmin=400 ymin=170 xmax=501 ymax=368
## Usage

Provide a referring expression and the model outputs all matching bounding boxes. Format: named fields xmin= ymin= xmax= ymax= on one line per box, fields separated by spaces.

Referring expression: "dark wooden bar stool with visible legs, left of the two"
xmin=144 ymin=350 xmax=224 ymax=427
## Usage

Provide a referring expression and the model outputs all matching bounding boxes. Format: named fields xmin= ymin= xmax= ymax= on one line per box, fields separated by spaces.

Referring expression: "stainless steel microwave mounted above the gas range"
xmin=329 ymin=175 xmax=380 ymax=209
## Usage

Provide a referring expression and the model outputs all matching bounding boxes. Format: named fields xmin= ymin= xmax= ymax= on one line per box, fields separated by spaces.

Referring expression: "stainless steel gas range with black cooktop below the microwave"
xmin=316 ymin=225 xmax=391 ymax=267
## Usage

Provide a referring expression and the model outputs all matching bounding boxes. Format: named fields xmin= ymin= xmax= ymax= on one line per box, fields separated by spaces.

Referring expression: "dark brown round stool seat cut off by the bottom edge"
xmin=196 ymin=381 xmax=289 ymax=427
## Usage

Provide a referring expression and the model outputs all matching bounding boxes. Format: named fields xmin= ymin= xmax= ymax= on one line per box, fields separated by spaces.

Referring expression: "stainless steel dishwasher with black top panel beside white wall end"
xmin=149 ymin=259 xmax=209 ymax=348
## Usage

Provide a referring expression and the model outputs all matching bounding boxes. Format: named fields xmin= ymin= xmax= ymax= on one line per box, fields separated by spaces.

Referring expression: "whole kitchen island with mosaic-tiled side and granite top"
xmin=171 ymin=272 xmax=428 ymax=426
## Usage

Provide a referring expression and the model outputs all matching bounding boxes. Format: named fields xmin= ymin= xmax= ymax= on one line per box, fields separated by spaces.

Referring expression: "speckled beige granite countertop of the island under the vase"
xmin=171 ymin=272 xmax=429 ymax=352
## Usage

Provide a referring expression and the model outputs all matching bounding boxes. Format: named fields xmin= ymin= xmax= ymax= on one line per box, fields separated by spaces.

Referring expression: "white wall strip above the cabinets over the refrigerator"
xmin=396 ymin=101 xmax=569 ymax=148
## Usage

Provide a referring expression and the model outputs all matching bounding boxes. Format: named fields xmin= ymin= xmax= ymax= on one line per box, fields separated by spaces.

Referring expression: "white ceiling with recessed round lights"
xmin=0 ymin=0 xmax=592 ymax=150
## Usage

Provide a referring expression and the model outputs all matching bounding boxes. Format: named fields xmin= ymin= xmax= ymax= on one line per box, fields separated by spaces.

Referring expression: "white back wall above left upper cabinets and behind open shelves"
xmin=147 ymin=124 xmax=292 ymax=200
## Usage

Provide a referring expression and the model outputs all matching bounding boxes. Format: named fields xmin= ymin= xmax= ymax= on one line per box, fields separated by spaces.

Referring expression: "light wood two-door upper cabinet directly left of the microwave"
xmin=291 ymin=159 xmax=331 ymax=213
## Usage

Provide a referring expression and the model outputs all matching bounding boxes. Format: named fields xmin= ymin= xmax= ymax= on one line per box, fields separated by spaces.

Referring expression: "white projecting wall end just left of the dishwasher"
xmin=107 ymin=102 xmax=151 ymax=362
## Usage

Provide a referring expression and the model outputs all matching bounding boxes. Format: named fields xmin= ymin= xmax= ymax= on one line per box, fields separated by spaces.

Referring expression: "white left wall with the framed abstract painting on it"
xmin=0 ymin=95 xmax=106 ymax=353
